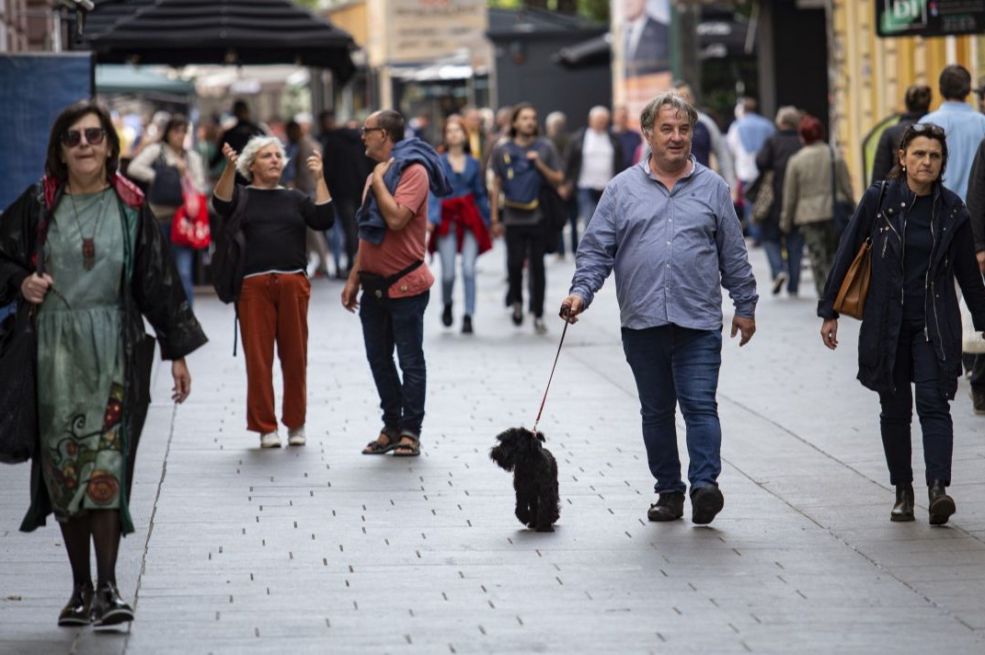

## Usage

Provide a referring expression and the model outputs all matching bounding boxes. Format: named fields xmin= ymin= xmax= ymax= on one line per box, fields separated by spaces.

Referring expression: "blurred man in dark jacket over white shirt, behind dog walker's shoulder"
xmin=564 ymin=106 xmax=624 ymax=252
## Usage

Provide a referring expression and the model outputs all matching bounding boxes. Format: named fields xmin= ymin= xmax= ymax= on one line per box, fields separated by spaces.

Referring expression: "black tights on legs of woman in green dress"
xmin=59 ymin=510 xmax=120 ymax=587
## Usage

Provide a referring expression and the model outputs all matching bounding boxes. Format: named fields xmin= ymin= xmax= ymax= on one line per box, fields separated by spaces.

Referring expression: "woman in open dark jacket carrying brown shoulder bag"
xmin=818 ymin=124 xmax=985 ymax=525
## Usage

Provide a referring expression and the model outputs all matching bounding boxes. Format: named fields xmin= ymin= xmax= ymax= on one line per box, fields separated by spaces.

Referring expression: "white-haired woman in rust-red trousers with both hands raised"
xmin=212 ymin=136 xmax=335 ymax=448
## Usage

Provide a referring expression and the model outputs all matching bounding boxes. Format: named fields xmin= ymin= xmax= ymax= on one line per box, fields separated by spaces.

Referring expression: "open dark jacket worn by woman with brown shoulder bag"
xmin=817 ymin=180 xmax=985 ymax=398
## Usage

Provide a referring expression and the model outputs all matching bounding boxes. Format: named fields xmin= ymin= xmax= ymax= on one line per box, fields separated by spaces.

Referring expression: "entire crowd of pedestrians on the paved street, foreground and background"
xmin=0 ymin=66 xmax=985 ymax=626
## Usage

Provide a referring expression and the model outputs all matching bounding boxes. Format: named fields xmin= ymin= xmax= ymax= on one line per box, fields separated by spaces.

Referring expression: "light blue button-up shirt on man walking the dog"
xmin=570 ymin=156 xmax=759 ymax=330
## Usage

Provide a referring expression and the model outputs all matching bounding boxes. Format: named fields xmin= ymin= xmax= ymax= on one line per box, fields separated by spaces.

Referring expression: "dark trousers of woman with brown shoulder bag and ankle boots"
xmin=879 ymin=321 xmax=954 ymax=485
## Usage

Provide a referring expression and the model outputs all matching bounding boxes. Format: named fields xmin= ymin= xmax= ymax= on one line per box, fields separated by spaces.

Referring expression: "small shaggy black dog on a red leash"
xmin=489 ymin=428 xmax=561 ymax=532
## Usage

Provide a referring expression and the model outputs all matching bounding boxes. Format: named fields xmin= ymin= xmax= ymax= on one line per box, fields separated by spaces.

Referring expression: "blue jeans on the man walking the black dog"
xmin=622 ymin=325 xmax=722 ymax=493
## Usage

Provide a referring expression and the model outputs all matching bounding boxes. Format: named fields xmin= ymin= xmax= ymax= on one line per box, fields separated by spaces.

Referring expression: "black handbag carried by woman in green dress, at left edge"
xmin=0 ymin=301 xmax=38 ymax=464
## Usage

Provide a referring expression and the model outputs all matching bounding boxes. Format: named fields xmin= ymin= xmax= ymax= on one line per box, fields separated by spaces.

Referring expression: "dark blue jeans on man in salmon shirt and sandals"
xmin=359 ymin=291 xmax=431 ymax=439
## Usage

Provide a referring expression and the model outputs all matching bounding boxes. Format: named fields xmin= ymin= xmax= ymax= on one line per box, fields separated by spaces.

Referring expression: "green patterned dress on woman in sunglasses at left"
xmin=38 ymin=189 xmax=133 ymax=521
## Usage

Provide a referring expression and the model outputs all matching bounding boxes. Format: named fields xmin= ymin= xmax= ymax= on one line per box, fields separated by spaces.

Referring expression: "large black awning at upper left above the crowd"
xmin=86 ymin=0 xmax=355 ymax=83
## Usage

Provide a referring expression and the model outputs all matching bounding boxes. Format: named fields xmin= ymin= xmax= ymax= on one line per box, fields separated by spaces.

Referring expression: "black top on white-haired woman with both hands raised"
xmin=212 ymin=185 xmax=335 ymax=275
